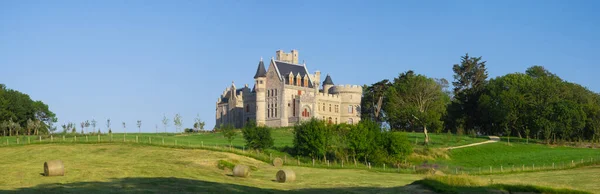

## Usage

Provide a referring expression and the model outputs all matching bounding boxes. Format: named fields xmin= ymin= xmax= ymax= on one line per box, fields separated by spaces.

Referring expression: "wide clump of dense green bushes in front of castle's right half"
xmin=294 ymin=119 xmax=412 ymax=164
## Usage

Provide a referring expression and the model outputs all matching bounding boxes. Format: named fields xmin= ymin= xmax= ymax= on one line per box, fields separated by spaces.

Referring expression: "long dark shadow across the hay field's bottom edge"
xmin=0 ymin=177 xmax=433 ymax=194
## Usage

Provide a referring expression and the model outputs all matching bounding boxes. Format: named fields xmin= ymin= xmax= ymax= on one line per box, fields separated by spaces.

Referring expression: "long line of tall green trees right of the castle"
xmin=361 ymin=54 xmax=600 ymax=143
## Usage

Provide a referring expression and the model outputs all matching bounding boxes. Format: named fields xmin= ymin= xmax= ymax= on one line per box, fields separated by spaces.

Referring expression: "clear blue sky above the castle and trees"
xmin=0 ymin=0 xmax=600 ymax=131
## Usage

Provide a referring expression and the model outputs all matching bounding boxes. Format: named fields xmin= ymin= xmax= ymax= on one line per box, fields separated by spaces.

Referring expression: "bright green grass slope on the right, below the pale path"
xmin=437 ymin=142 xmax=600 ymax=171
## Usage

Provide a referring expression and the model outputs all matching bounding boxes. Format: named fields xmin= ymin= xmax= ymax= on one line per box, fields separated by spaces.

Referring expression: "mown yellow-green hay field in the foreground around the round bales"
xmin=0 ymin=144 xmax=422 ymax=193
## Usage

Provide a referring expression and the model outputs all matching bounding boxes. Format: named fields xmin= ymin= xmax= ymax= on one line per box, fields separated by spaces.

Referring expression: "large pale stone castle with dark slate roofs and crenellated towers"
xmin=215 ymin=50 xmax=363 ymax=128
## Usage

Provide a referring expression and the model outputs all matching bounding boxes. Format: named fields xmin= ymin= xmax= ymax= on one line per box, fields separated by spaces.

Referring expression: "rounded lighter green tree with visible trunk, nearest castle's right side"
xmin=385 ymin=71 xmax=449 ymax=143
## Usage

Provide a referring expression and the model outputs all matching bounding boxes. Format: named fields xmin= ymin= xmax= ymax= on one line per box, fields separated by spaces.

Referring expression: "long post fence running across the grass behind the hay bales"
xmin=0 ymin=135 xmax=600 ymax=175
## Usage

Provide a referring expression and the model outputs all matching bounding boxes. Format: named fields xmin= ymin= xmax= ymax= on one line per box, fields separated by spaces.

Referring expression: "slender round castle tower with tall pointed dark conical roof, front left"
xmin=254 ymin=58 xmax=267 ymax=126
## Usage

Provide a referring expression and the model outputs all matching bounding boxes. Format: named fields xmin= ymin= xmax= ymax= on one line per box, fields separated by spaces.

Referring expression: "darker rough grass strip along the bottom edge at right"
xmin=416 ymin=176 xmax=589 ymax=194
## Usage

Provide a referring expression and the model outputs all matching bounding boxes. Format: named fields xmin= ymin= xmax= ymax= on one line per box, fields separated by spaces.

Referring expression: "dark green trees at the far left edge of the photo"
xmin=0 ymin=84 xmax=57 ymax=136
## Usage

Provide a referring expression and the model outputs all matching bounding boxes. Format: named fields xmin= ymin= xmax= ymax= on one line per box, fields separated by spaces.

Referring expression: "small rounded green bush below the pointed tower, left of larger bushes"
xmin=242 ymin=121 xmax=275 ymax=150
